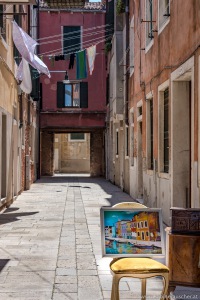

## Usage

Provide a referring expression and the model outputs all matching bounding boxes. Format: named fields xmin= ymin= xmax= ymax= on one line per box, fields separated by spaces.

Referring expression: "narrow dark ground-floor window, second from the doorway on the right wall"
xmin=147 ymin=98 xmax=153 ymax=170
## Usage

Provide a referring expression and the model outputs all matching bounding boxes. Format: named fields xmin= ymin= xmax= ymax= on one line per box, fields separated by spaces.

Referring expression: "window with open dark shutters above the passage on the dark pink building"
xmin=57 ymin=81 xmax=88 ymax=108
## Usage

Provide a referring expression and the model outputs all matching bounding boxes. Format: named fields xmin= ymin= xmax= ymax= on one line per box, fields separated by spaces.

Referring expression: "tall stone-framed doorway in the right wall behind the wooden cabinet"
xmin=172 ymin=80 xmax=192 ymax=208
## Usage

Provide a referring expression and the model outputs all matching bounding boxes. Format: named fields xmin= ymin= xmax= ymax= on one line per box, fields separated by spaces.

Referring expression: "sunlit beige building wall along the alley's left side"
xmin=0 ymin=4 xmax=38 ymax=209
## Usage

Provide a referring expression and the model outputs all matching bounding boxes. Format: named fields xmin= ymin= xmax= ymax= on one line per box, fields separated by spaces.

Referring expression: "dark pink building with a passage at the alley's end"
xmin=39 ymin=3 xmax=108 ymax=175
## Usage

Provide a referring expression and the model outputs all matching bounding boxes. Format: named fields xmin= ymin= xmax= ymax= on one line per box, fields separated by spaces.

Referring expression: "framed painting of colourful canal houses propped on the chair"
xmin=100 ymin=207 xmax=165 ymax=257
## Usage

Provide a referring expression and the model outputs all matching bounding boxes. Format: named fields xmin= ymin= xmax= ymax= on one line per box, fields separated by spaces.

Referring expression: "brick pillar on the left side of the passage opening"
xmin=41 ymin=132 xmax=54 ymax=176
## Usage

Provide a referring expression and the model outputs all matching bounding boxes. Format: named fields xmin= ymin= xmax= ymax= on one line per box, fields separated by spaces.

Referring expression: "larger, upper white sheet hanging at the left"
xmin=12 ymin=21 xmax=51 ymax=78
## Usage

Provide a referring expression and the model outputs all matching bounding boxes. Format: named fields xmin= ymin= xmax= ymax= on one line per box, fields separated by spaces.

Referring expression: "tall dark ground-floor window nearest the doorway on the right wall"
xmin=163 ymin=88 xmax=169 ymax=173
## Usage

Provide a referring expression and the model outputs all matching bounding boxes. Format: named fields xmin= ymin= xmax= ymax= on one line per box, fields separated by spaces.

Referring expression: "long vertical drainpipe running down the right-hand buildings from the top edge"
xmin=125 ymin=0 xmax=130 ymax=125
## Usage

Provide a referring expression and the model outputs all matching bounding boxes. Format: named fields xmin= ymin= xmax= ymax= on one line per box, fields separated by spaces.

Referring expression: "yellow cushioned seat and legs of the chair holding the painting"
xmin=110 ymin=257 xmax=169 ymax=300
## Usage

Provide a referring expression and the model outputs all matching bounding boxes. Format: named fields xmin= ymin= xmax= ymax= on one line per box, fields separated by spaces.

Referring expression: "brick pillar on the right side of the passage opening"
xmin=90 ymin=130 xmax=104 ymax=176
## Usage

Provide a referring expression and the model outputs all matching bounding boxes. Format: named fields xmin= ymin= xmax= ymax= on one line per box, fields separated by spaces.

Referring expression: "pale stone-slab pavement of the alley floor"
xmin=0 ymin=176 xmax=200 ymax=300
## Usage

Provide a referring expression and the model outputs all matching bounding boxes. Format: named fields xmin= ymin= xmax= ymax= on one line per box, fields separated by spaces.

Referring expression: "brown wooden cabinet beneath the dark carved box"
xmin=167 ymin=231 xmax=200 ymax=290
